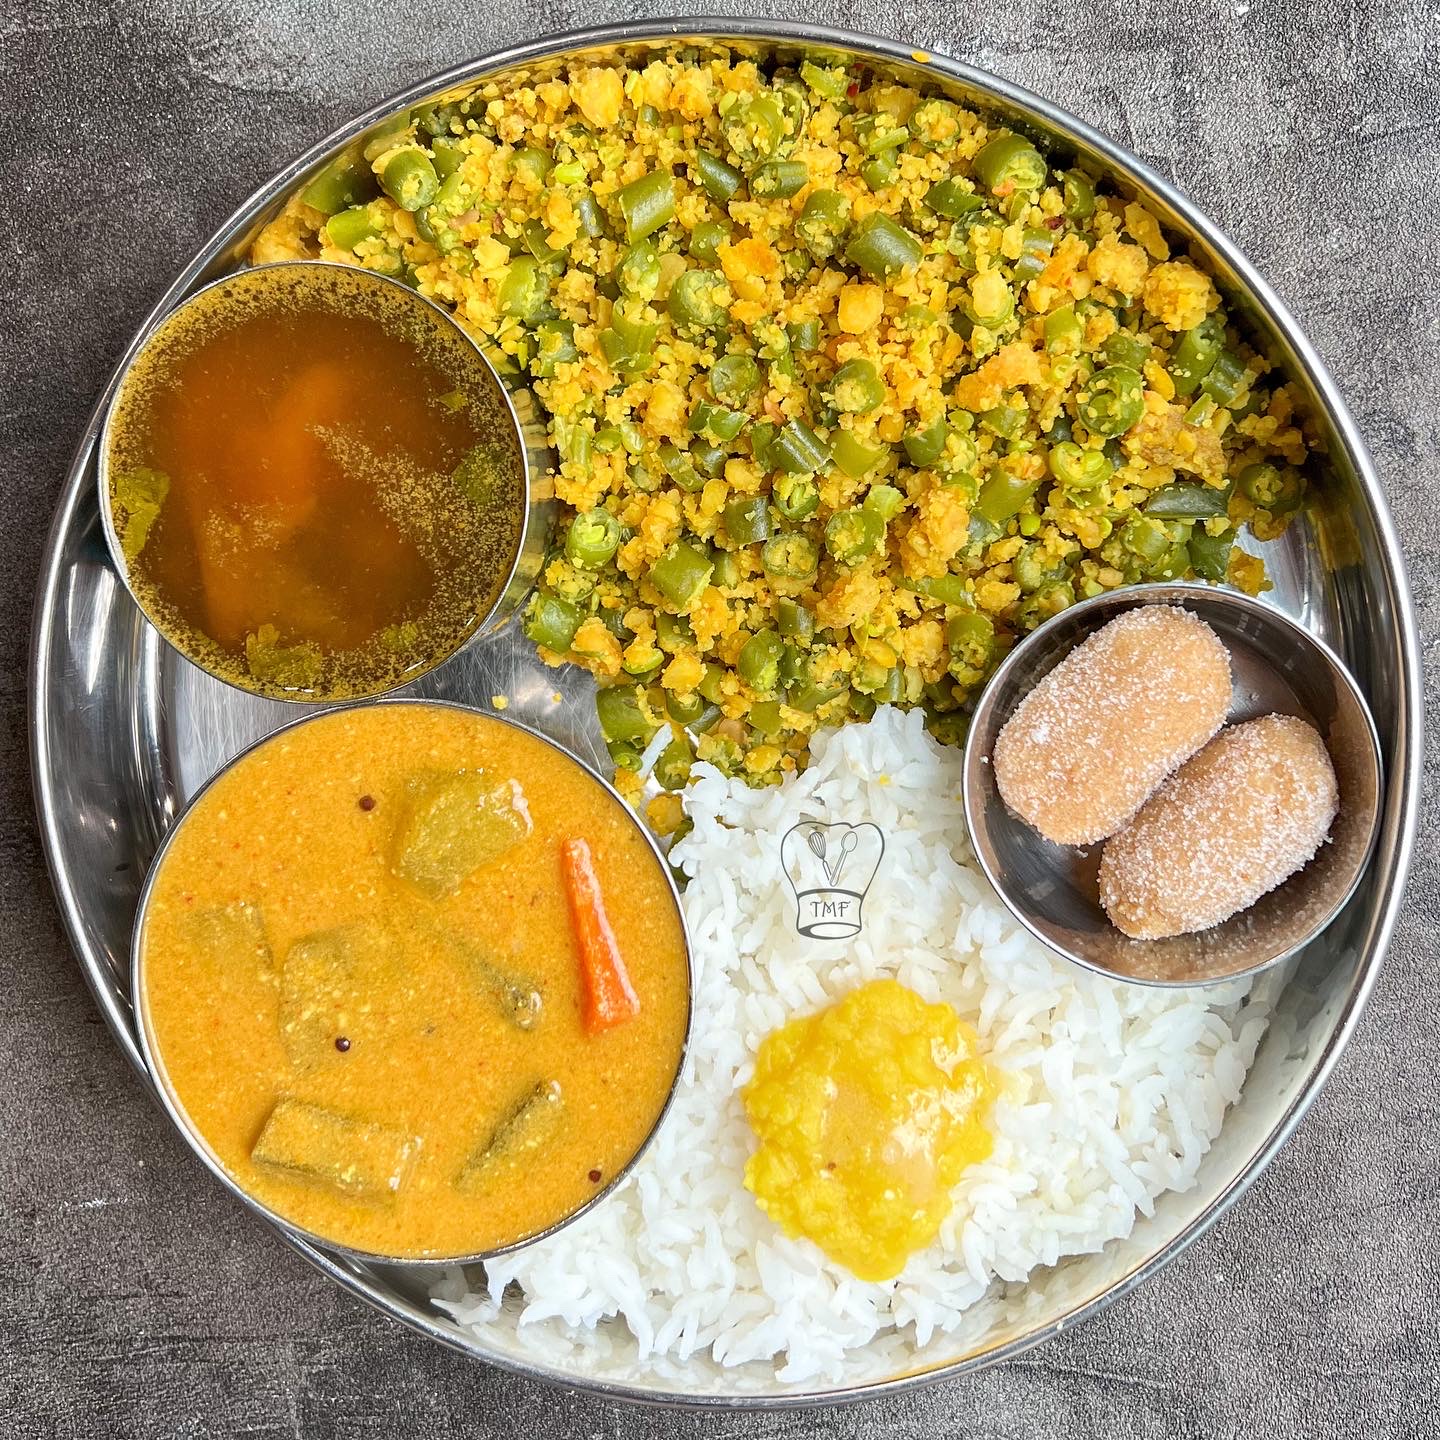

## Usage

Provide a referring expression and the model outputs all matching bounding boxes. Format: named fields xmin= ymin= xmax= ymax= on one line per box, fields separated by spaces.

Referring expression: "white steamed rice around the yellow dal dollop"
xmin=433 ymin=708 xmax=1269 ymax=1382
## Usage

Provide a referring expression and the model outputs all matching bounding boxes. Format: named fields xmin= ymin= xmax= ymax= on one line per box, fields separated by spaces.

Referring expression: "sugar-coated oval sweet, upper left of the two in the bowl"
xmin=994 ymin=605 xmax=1230 ymax=845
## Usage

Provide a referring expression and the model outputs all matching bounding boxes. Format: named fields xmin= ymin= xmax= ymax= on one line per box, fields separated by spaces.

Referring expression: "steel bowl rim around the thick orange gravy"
xmin=130 ymin=697 xmax=696 ymax=1269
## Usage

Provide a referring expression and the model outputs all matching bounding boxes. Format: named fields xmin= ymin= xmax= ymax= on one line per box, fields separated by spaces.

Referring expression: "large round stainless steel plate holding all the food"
xmin=30 ymin=19 xmax=1421 ymax=1407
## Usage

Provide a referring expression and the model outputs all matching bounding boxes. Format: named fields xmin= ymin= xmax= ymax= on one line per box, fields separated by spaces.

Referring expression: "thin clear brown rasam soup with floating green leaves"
xmin=107 ymin=265 xmax=526 ymax=697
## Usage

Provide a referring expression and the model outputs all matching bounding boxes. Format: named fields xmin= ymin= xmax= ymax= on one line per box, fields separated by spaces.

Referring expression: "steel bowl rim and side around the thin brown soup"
xmin=96 ymin=261 xmax=554 ymax=704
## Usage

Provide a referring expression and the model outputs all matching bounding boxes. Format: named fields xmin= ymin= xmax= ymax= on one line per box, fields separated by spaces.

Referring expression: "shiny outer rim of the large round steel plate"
xmin=27 ymin=14 xmax=1424 ymax=1411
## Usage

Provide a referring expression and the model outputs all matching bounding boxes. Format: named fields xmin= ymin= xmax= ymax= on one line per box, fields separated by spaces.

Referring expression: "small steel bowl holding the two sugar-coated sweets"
xmin=965 ymin=585 xmax=1381 ymax=986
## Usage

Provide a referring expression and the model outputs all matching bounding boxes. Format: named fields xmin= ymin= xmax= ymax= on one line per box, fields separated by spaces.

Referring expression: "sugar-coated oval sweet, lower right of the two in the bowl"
xmin=1100 ymin=716 xmax=1339 ymax=940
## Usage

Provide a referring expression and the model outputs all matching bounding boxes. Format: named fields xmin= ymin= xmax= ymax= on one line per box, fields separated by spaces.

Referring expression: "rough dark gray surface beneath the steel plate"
xmin=0 ymin=0 xmax=1440 ymax=1440
